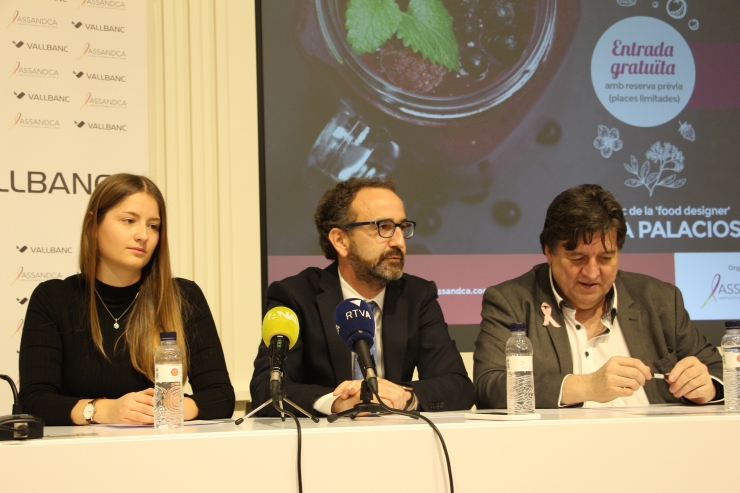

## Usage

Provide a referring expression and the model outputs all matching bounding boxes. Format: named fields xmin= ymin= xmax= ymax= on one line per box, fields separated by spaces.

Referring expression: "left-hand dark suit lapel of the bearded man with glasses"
xmin=316 ymin=263 xmax=353 ymax=385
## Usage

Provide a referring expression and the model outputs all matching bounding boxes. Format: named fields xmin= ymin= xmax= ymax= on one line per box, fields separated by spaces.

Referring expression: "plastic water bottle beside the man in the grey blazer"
xmin=506 ymin=323 xmax=534 ymax=414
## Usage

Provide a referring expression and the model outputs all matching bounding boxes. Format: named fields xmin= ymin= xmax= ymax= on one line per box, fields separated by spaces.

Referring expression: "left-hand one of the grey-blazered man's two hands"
xmin=561 ymin=356 xmax=652 ymax=406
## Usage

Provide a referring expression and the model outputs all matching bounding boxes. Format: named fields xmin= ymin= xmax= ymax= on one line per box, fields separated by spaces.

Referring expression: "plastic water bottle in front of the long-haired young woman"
xmin=154 ymin=332 xmax=185 ymax=430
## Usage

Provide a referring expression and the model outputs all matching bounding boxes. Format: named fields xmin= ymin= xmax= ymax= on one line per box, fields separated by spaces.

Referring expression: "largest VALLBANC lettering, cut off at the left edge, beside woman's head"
xmin=0 ymin=170 xmax=110 ymax=194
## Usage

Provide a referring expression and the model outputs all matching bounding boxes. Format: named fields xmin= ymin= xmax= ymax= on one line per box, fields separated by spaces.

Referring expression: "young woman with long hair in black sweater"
xmin=20 ymin=174 xmax=234 ymax=425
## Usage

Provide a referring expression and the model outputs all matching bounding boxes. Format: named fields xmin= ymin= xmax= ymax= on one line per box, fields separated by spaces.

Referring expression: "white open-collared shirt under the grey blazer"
xmin=550 ymin=268 xmax=650 ymax=407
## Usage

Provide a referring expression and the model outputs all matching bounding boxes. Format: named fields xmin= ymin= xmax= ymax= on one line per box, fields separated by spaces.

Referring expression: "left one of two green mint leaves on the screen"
xmin=344 ymin=0 xmax=403 ymax=55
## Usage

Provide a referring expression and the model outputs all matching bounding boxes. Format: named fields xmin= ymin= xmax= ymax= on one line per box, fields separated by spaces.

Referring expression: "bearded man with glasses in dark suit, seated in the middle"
xmin=250 ymin=178 xmax=474 ymax=416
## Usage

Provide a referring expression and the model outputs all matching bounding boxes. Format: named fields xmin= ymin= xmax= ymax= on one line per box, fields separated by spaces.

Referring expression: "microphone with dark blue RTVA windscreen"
xmin=334 ymin=298 xmax=378 ymax=394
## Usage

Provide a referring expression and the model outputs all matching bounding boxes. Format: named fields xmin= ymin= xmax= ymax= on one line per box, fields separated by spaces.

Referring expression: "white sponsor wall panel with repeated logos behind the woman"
xmin=0 ymin=0 xmax=149 ymax=415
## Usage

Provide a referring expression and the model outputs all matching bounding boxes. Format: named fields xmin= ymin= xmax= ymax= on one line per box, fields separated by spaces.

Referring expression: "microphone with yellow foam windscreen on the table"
xmin=262 ymin=306 xmax=299 ymax=398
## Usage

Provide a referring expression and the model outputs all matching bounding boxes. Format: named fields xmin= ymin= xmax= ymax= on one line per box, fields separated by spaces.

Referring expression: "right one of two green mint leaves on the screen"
xmin=396 ymin=0 xmax=460 ymax=71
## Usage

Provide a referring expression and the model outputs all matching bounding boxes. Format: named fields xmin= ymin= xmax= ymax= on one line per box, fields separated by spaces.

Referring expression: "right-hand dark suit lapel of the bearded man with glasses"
xmin=382 ymin=280 xmax=408 ymax=382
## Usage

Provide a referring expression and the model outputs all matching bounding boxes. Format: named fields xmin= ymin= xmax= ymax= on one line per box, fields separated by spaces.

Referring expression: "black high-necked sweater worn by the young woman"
xmin=19 ymin=275 xmax=234 ymax=425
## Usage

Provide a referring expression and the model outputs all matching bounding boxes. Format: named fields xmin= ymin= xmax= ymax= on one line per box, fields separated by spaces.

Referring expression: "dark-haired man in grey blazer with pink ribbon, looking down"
xmin=473 ymin=185 xmax=723 ymax=408
